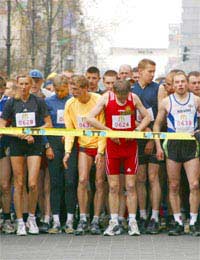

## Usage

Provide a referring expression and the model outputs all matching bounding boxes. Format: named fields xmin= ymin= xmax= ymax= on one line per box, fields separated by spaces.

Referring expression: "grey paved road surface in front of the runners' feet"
xmin=0 ymin=234 xmax=200 ymax=260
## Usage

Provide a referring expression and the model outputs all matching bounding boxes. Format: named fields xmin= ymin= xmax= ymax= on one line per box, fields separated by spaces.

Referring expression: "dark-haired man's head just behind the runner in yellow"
xmin=86 ymin=67 xmax=100 ymax=92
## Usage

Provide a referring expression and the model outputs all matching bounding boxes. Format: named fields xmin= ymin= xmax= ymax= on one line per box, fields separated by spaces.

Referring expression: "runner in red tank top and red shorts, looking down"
xmin=87 ymin=80 xmax=150 ymax=236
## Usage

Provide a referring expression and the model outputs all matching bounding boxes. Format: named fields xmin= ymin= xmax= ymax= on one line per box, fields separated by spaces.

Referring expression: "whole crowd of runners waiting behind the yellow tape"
xmin=0 ymin=59 xmax=200 ymax=236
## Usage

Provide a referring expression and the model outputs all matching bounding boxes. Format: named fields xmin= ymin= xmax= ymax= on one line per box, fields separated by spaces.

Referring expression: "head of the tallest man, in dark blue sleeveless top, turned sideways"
xmin=138 ymin=59 xmax=156 ymax=85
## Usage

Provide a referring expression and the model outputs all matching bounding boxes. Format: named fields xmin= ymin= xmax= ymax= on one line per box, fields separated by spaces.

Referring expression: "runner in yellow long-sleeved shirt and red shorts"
xmin=63 ymin=76 xmax=106 ymax=235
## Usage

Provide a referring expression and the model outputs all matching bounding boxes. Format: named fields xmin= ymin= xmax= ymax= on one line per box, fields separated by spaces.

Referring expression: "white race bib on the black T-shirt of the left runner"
xmin=15 ymin=112 xmax=35 ymax=127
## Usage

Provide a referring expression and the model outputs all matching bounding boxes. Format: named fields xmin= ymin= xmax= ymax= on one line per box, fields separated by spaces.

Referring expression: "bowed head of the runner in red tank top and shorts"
xmin=113 ymin=79 xmax=131 ymax=104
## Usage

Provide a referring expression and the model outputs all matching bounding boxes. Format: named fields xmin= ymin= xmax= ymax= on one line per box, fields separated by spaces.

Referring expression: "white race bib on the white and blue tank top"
xmin=175 ymin=113 xmax=194 ymax=132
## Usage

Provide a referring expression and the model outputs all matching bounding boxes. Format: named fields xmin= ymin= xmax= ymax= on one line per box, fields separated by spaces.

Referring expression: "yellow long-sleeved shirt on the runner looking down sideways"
xmin=64 ymin=93 xmax=106 ymax=153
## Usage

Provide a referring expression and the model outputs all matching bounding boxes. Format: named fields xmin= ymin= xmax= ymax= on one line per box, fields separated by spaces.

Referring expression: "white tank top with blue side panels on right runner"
xmin=167 ymin=92 xmax=198 ymax=133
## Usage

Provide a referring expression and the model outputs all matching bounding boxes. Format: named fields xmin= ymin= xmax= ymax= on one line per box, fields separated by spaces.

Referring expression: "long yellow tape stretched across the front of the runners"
xmin=0 ymin=127 xmax=195 ymax=140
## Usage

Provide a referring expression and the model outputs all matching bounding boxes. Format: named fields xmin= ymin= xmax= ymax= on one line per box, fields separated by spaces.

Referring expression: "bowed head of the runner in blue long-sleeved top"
xmin=53 ymin=75 xmax=69 ymax=99
